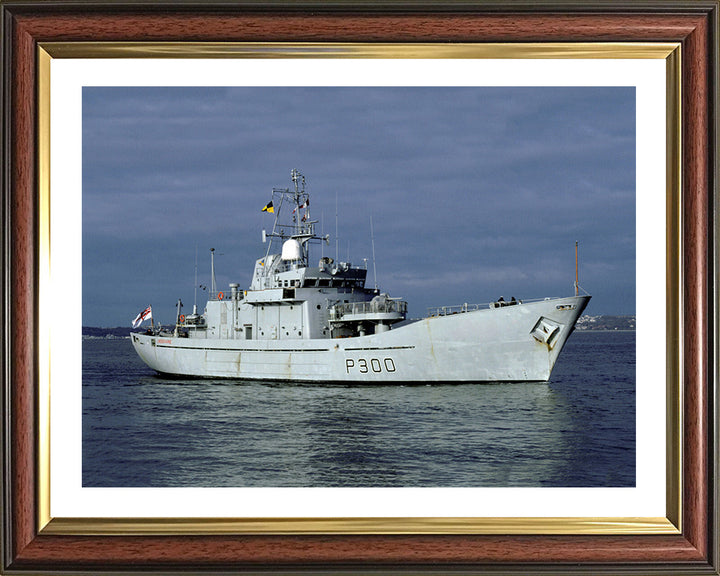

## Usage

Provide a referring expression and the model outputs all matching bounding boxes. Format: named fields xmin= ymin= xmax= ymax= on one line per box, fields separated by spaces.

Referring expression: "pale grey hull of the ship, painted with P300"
xmin=132 ymin=296 xmax=590 ymax=384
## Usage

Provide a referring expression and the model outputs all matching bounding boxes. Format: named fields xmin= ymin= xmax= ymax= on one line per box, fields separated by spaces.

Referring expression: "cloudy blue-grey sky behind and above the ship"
xmin=82 ymin=87 xmax=635 ymax=326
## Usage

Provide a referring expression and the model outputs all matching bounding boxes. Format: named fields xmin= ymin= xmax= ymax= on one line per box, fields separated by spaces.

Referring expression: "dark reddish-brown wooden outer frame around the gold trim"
xmin=0 ymin=0 xmax=719 ymax=574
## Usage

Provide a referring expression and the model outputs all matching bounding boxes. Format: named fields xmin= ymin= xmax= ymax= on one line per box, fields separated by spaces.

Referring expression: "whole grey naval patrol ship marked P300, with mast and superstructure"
xmin=131 ymin=170 xmax=590 ymax=384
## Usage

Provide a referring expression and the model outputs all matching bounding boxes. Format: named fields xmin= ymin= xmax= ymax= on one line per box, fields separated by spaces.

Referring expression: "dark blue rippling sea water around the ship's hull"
xmin=82 ymin=331 xmax=635 ymax=487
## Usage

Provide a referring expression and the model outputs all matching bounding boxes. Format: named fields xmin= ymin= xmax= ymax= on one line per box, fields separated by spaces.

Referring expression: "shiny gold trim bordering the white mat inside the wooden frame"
xmin=37 ymin=42 xmax=682 ymax=535
